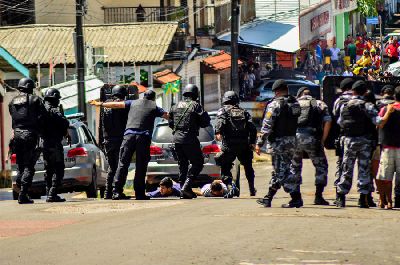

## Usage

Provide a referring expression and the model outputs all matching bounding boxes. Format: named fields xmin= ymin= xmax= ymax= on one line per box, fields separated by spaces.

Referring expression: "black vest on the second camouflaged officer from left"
xmin=297 ymin=99 xmax=321 ymax=129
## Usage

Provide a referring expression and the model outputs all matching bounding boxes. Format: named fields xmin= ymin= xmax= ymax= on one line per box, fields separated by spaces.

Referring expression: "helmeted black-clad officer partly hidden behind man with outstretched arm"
xmin=101 ymin=85 xmax=129 ymax=200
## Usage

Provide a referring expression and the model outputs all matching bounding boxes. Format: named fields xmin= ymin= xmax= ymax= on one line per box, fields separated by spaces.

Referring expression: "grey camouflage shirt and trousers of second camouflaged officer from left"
xmin=290 ymin=95 xmax=332 ymax=186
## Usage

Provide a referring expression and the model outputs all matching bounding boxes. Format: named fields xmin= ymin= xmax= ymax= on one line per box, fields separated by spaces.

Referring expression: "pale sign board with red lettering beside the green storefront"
xmin=299 ymin=1 xmax=332 ymax=46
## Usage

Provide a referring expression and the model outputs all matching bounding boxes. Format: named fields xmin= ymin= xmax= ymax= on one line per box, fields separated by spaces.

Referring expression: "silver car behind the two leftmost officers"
xmin=11 ymin=116 xmax=108 ymax=199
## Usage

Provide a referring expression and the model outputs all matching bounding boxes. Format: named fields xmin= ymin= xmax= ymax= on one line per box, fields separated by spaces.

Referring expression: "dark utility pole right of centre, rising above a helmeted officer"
xmin=231 ymin=0 xmax=240 ymax=95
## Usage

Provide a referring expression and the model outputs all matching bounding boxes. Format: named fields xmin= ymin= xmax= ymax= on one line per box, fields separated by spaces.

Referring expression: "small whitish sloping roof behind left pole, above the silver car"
xmin=46 ymin=76 xmax=104 ymax=110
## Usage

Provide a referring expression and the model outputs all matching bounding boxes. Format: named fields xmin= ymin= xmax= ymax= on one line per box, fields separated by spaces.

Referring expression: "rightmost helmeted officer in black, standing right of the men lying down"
xmin=215 ymin=91 xmax=257 ymax=198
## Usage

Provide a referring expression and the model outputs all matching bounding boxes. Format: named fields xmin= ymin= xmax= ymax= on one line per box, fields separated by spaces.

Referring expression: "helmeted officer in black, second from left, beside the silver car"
xmin=42 ymin=88 xmax=69 ymax=202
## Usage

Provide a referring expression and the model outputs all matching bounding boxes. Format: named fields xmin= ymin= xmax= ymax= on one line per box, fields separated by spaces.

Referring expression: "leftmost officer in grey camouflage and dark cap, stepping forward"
xmin=256 ymin=79 xmax=303 ymax=208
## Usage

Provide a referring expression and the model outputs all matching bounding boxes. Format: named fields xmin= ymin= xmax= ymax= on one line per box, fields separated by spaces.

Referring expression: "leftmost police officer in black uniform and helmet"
xmin=8 ymin=78 xmax=46 ymax=204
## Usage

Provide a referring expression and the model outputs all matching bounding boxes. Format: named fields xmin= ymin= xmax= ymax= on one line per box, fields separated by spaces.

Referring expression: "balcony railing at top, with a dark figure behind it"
xmin=103 ymin=6 xmax=187 ymax=24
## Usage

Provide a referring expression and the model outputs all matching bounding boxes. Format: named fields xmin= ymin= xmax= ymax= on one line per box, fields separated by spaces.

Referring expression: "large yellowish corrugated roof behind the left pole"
xmin=0 ymin=22 xmax=178 ymax=64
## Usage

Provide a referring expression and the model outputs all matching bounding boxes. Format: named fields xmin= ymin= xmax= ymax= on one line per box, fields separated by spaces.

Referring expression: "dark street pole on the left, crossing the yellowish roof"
xmin=75 ymin=0 xmax=87 ymax=120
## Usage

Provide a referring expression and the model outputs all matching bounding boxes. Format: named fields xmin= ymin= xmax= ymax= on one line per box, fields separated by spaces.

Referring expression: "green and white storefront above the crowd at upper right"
xmin=332 ymin=0 xmax=360 ymax=49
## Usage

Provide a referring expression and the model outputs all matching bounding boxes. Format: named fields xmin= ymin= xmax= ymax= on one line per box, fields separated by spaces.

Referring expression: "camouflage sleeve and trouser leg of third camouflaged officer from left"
xmin=332 ymin=91 xmax=353 ymax=187
